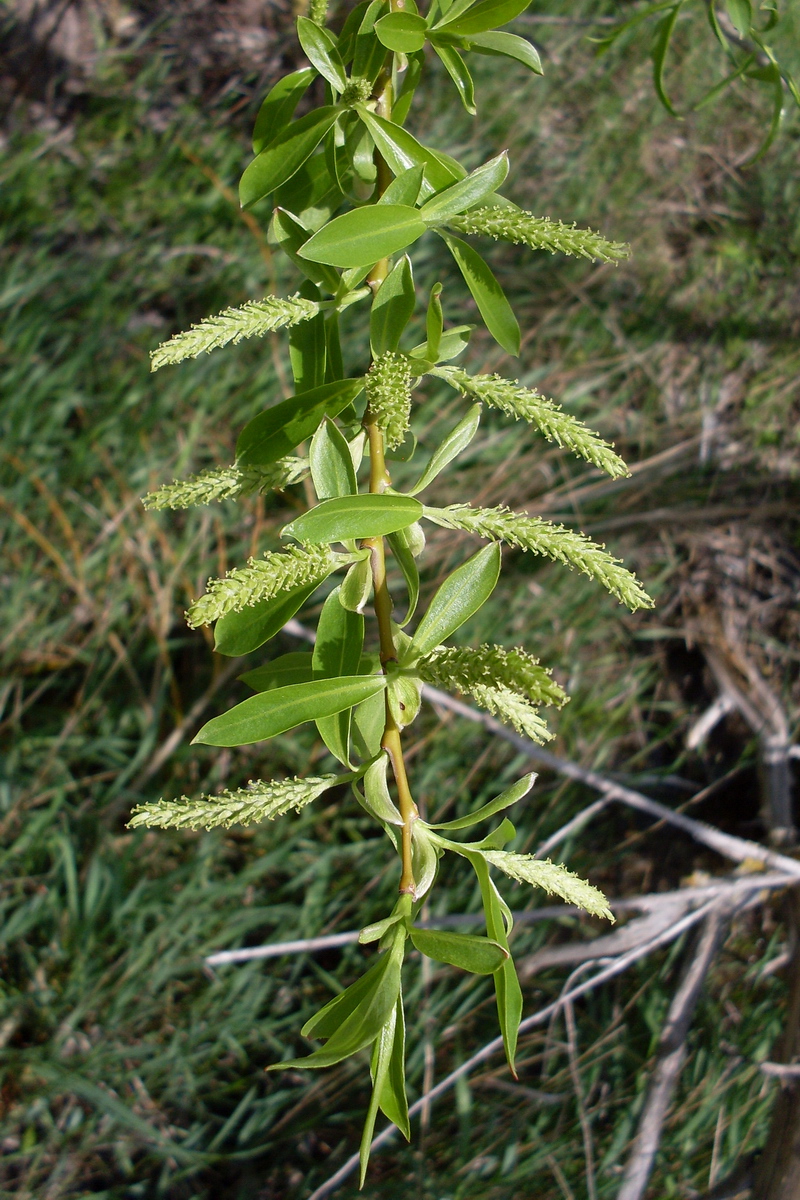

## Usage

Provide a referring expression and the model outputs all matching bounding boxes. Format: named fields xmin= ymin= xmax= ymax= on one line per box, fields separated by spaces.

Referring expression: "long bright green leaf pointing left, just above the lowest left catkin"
xmin=192 ymin=676 xmax=386 ymax=746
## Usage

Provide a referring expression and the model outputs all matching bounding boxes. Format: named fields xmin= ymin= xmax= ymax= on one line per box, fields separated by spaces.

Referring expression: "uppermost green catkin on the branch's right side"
xmin=447 ymin=204 xmax=631 ymax=263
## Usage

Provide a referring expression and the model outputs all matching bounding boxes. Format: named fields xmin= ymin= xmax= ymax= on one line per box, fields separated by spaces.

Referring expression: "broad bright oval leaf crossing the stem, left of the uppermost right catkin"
xmin=300 ymin=204 xmax=427 ymax=266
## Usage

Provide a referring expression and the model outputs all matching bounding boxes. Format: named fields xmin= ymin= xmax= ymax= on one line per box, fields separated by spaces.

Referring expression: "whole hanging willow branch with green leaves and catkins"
xmin=131 ymin=0 xmax=651 ymax=1180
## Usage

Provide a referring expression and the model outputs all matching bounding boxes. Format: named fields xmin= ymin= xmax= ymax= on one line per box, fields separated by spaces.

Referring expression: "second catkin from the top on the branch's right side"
xmin=431 ymin=367 xmax=630 ymax=479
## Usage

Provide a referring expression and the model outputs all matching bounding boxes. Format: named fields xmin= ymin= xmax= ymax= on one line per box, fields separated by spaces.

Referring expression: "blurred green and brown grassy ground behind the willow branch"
xmin=0 ymin=0 xmax=800 ymax=1200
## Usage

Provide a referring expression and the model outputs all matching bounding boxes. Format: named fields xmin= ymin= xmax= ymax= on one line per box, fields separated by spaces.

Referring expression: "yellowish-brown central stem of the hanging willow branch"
xmin=363 ymin=51 xmax=419 ymax=896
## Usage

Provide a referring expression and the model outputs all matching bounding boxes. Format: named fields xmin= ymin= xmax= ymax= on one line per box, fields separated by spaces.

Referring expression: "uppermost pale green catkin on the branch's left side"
xmin=150 ymin=295 xmax=319 ymax=371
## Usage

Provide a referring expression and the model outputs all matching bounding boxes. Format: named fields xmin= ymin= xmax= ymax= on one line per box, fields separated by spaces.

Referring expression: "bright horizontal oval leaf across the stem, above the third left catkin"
xmin=281 ymin=493 xmax=422 ymax=545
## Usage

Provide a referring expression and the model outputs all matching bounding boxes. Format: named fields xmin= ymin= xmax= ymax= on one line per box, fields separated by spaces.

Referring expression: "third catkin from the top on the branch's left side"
xmin=186 ymin=546 xmax=350 ymax=629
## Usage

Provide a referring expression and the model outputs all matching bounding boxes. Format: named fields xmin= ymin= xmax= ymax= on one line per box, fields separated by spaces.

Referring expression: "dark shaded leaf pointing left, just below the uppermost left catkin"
xmin=236 ymin=378 xmax=363 ymax=467
